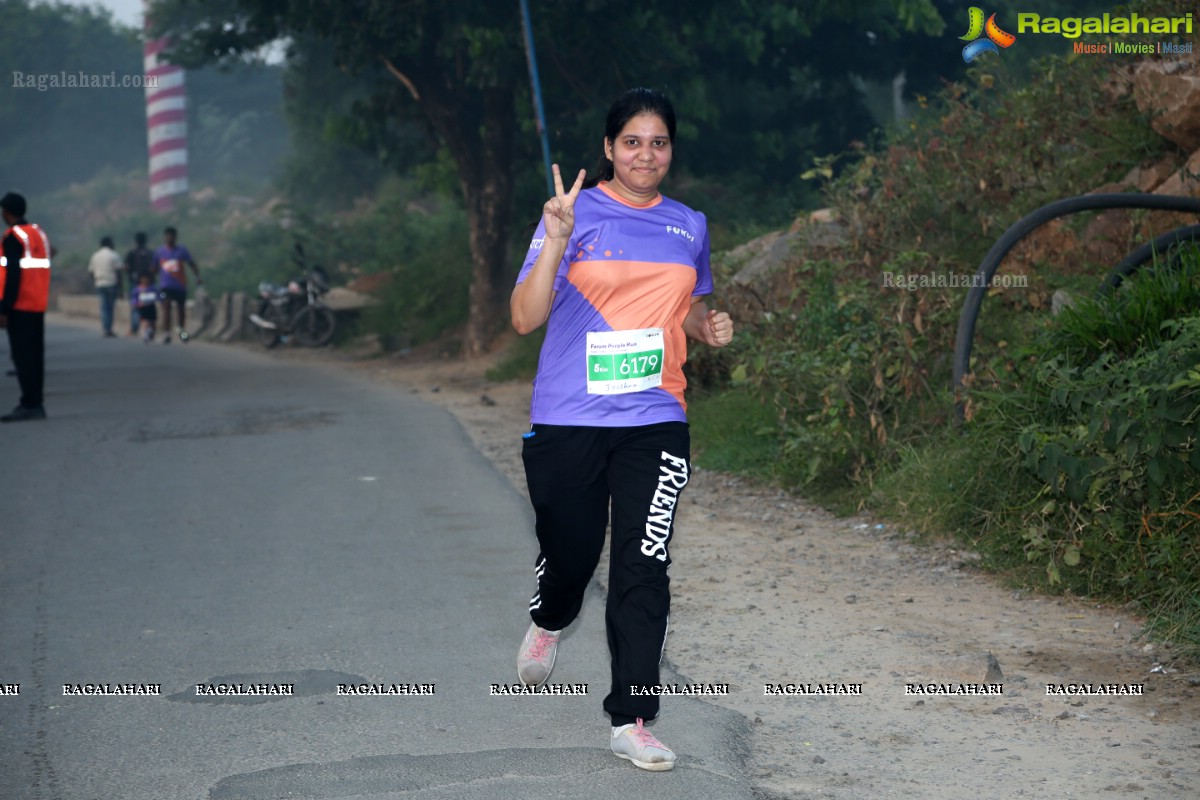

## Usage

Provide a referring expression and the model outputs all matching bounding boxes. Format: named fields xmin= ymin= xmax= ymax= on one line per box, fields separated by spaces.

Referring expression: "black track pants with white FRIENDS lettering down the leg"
xmin=522 ymin=422 xmax=691 ymax=724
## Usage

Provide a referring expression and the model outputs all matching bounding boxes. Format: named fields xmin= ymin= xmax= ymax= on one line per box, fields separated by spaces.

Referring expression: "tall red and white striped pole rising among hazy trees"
xmin=142 ymin=2 xmax=187 ymax=211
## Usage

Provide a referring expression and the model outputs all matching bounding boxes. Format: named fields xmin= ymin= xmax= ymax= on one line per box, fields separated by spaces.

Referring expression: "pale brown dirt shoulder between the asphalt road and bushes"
xmin=255 ymin=340 xmax=1200 ymax=800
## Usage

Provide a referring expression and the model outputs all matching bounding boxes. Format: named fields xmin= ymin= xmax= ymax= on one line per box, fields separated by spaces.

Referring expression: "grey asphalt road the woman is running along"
xmin=0 ymin=324 xmax=751 ymax=800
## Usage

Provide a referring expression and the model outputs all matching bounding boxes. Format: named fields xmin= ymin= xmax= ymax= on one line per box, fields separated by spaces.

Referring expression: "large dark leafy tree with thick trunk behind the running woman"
xmin=151 ymin=0 xmax=942 ymax=354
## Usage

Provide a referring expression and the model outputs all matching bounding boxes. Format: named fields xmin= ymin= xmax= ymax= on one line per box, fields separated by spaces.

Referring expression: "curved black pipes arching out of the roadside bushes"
xmin=954 ymin=193 xmax=1200 ymax=422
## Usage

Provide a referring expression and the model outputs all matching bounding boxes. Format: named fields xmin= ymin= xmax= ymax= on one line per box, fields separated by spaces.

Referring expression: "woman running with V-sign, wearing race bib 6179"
xmin=511 ymin=89 xmax=733 ymax=771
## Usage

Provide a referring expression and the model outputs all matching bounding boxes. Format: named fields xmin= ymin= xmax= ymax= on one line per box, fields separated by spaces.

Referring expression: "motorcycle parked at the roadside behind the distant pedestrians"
xmin=250 ymin=243 xmax=335 ymax=348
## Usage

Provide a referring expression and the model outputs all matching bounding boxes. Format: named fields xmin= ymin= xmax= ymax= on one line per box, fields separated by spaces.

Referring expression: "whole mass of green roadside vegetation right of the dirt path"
xmin=694 ymin=53 xmax=1200 ymax=656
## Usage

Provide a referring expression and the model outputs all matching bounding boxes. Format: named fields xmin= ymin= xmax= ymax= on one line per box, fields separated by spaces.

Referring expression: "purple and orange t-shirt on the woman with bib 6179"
xmin=517 ymin=184 xmax=713 ymax=427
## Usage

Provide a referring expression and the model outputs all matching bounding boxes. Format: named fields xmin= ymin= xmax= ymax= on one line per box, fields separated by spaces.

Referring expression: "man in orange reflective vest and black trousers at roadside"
xmin=0 ymin=192 xmax=50 ymax=422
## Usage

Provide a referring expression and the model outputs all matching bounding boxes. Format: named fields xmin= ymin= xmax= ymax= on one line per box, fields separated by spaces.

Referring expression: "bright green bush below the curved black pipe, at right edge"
xmin=871 ymin=254 xmax=1200 ymax=655
